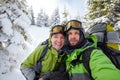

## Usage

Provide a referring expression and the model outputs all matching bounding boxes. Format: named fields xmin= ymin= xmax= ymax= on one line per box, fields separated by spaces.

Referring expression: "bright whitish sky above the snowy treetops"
xmin=27 ymin=0 xmax=86 ymax=16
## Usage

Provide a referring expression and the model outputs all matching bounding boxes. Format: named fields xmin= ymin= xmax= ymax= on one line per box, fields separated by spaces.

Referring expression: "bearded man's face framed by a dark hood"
xmin=67 ymin=29 xmax=80 ymax=46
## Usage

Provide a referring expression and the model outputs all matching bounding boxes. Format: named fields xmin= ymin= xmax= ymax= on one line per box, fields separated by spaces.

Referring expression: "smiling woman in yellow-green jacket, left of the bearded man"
xmin=21 ymin=25 xmax=65 ymax=80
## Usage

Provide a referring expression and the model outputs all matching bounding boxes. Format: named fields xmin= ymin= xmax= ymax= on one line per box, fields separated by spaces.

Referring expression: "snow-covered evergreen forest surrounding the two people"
xmin=0 ymin=0 xmax=120 ymax=80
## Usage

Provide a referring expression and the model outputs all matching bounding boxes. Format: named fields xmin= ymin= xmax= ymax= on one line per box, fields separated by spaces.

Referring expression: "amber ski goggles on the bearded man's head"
xmin=65 ymin=20 xmax=82 ymax=31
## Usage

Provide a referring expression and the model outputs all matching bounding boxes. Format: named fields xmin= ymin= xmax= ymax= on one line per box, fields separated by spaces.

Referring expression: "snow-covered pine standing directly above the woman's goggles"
xmin=50 ymin=8 xmax=60 ymax=27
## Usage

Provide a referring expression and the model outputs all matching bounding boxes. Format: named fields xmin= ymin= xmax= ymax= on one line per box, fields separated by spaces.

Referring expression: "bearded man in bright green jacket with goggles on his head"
xmin=64 ymin=20 xmax=120 ymax=80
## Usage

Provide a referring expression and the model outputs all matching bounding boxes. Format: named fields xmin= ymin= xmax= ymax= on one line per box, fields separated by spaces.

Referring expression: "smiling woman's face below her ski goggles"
xmin=51 ymin=33 xmax=65 ymax=50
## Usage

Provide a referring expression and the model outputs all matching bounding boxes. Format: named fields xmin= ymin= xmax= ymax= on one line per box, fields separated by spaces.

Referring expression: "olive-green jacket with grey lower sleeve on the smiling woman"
xmin=21 ymin=38 xmax=65 ymax=80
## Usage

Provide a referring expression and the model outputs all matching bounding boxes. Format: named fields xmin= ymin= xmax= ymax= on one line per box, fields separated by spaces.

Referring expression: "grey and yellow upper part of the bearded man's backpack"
xmin=86 ymin=23 xmax=120 ymax=50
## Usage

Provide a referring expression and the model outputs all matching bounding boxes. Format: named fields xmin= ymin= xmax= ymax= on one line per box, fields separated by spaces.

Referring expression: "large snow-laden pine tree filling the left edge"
xmin=0 ymin=0 xmax=31 ymax=74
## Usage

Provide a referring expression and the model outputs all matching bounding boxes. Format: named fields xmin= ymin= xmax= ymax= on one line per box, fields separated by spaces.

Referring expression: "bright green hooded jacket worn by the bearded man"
xmin=66 ymin=36 xmax=120 ymax=80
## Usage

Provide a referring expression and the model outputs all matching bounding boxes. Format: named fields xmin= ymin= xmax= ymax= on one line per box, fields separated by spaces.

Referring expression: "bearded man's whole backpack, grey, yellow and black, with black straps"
xmin=71 ymin=23 xmax=120 ymax=80
